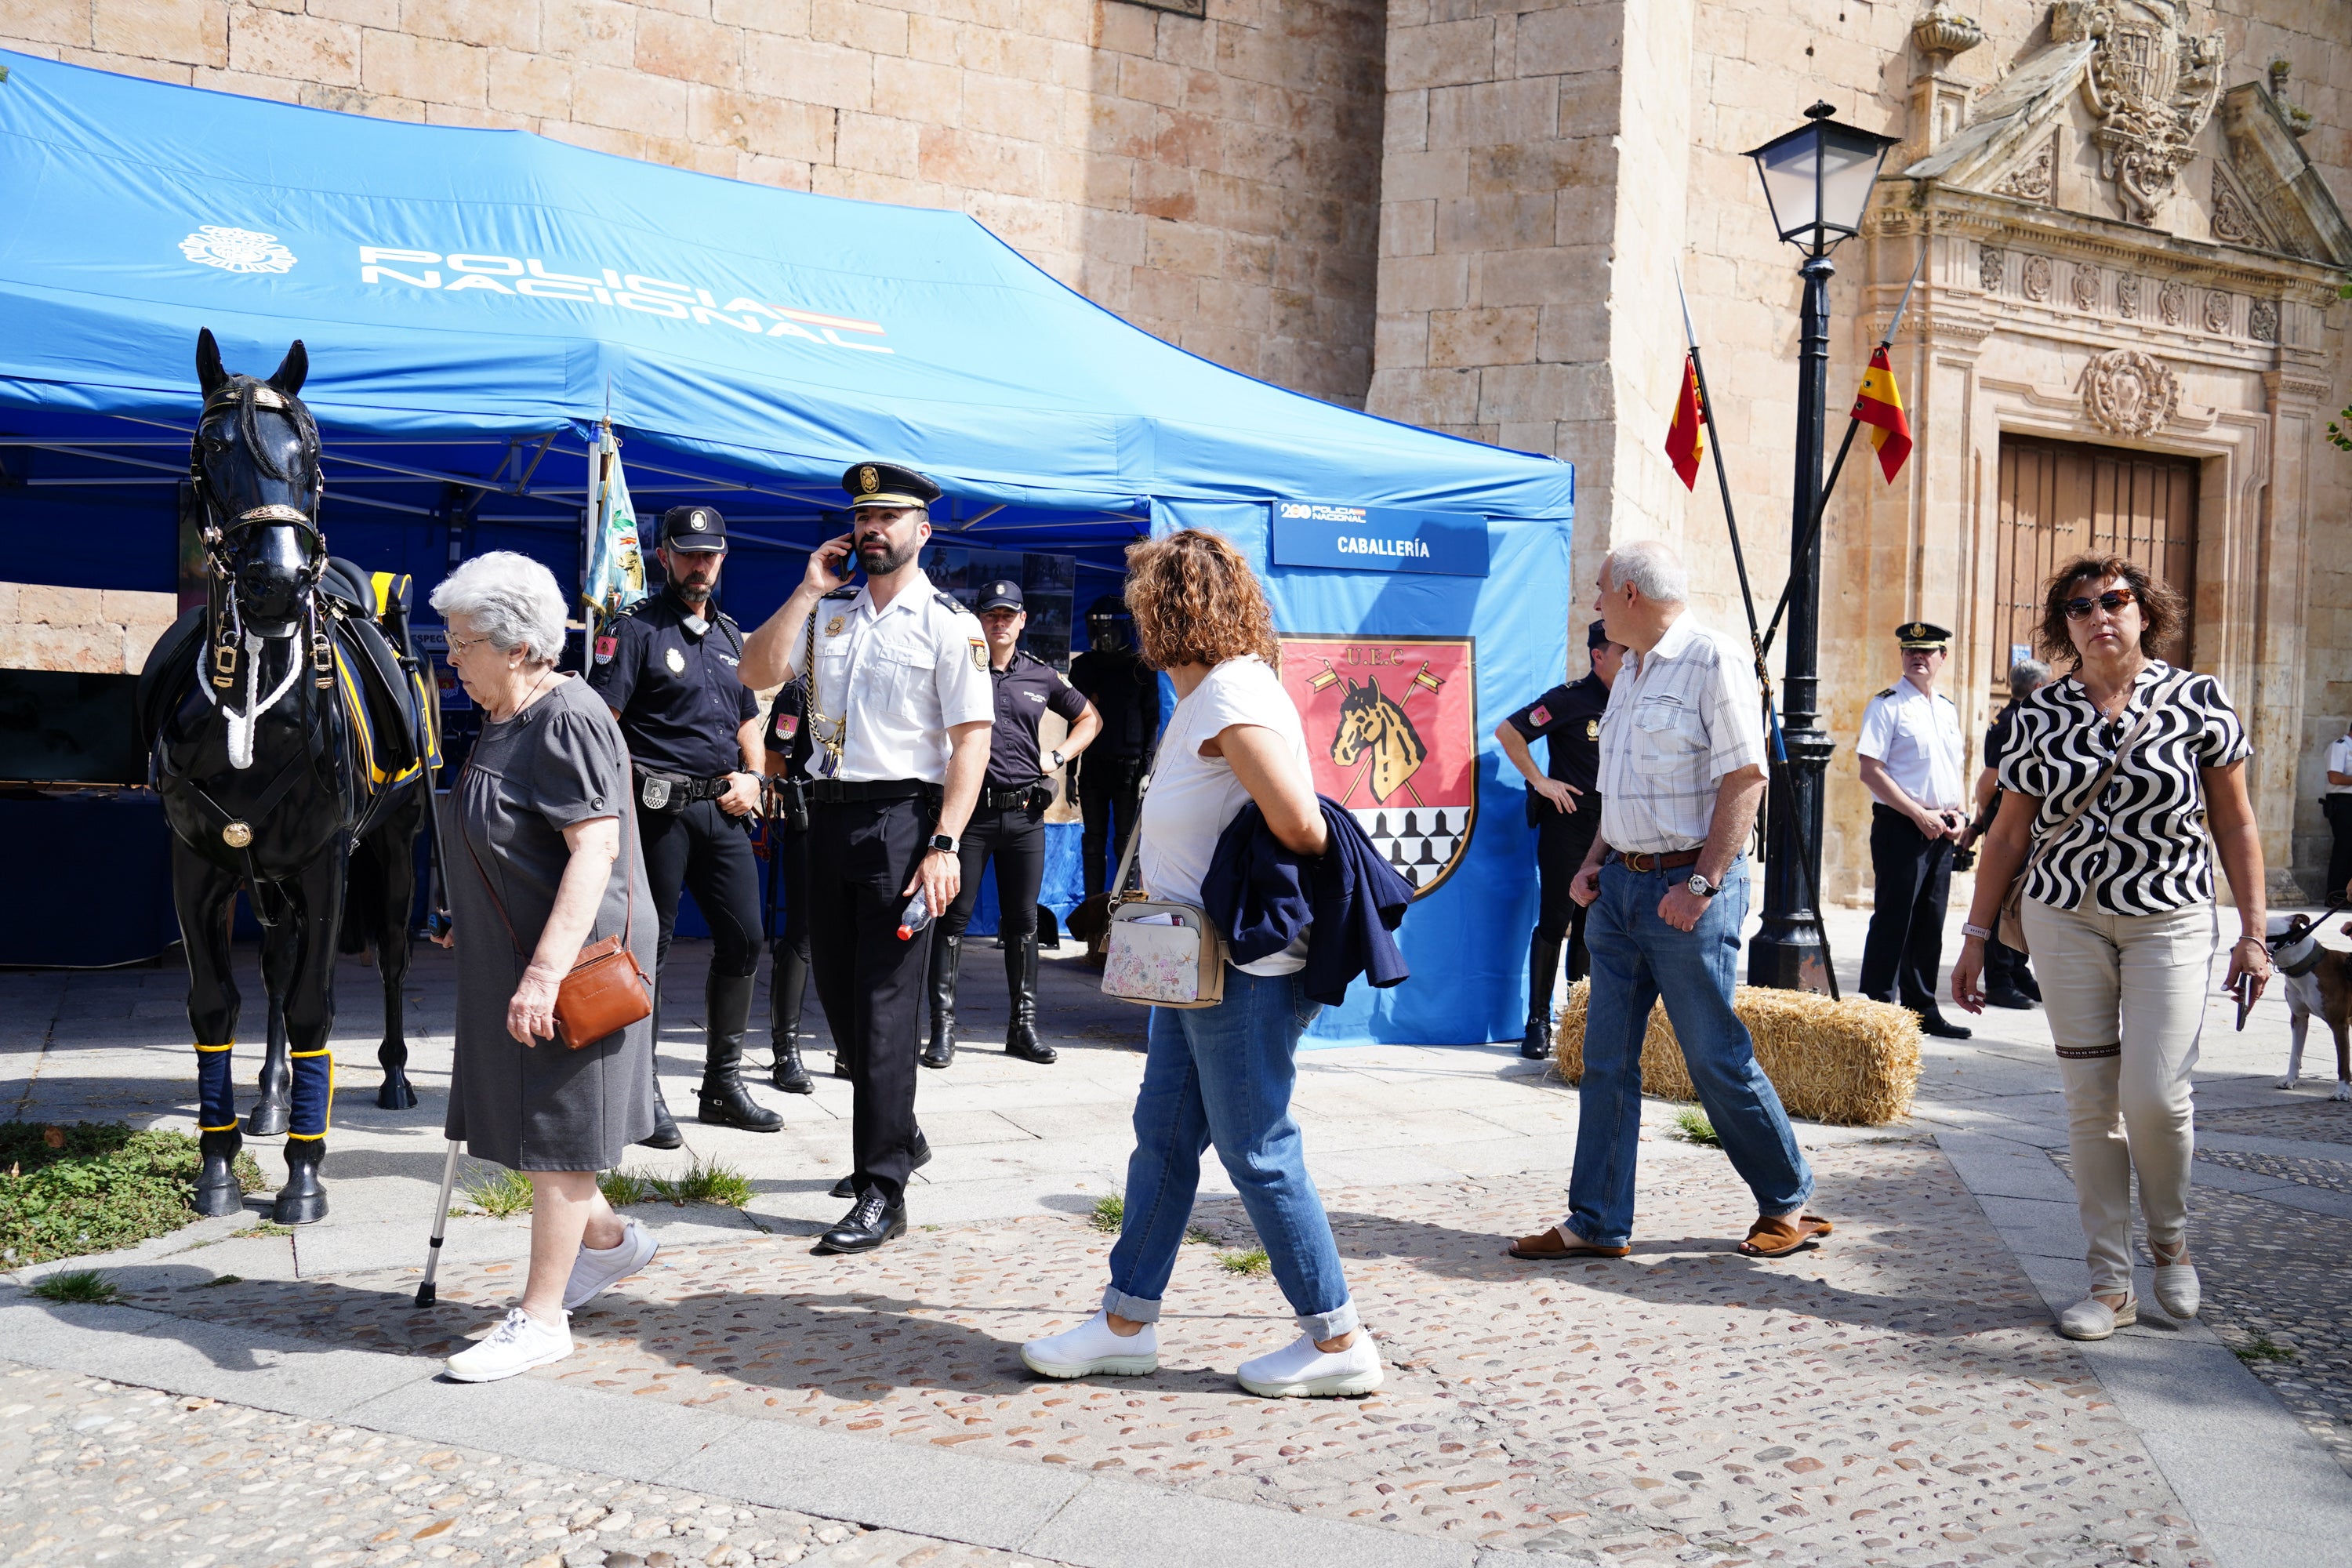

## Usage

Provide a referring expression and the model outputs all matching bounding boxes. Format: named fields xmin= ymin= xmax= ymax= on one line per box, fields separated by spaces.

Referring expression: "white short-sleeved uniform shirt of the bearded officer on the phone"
xmin=793 ymin=572 xmax=997 ymax=785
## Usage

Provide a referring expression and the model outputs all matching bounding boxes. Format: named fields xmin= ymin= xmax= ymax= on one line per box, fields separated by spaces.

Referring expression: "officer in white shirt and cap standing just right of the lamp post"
xmin=1853 ymin=621 xmax=1969 ymax=1039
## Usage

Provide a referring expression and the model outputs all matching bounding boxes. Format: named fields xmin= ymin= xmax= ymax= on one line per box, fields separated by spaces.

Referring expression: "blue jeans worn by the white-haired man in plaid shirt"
xmin=1566 ymin=855 xmax=1813 ymax=1246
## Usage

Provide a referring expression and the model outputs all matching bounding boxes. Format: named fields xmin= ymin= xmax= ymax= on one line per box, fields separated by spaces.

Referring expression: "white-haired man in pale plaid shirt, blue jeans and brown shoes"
xmin=1510 ymin=541 xmax=1830 ymax=1262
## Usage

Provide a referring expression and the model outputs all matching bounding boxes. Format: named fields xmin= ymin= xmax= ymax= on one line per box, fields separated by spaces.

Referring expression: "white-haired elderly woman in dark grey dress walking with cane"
xmin=433 ymin=550 xmax=659 ymax=1382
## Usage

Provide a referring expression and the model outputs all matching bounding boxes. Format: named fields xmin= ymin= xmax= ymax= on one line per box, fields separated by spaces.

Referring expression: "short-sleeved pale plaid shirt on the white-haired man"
xmin=1599 ymin=612 xmax=1764 ymax=855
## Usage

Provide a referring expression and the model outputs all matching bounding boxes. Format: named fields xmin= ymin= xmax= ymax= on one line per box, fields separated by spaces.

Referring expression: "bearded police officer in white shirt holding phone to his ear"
xmin=743 ymin=463 xmax=995 ymax=1253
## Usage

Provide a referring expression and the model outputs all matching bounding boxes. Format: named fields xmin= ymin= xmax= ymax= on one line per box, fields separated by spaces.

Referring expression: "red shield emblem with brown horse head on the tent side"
xmin=1282 ymin=635 xmax=1477 ymax=898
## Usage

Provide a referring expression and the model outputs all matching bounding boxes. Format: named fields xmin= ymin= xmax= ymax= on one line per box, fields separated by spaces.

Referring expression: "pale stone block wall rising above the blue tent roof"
xmin=0 ymin=0 xmax=1381 ymax=407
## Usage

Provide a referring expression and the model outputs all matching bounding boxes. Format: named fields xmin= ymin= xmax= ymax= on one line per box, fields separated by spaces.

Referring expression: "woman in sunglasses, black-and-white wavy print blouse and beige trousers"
xmin=1952 ymin=555 xmax=2270 ymax=1340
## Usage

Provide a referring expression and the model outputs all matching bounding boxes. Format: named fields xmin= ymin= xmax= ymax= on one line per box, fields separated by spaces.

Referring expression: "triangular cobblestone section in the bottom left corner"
xmin=0 ymin=1361 xmax=1042 ymax=1568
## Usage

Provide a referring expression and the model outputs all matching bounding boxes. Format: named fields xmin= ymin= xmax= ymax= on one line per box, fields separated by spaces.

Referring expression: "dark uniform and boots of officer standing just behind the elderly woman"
xmin=588 ymin=590 xmax=783 ymax=1131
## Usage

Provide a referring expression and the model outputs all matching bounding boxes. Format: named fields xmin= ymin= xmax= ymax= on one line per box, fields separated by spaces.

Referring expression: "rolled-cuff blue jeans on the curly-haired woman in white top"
xmin=1103 ymin=966 xmax=1357 ymax=1340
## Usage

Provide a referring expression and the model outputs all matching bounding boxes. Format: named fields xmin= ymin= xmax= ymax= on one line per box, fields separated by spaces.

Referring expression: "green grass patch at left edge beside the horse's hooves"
xmin=0 ymin=1121 xmax=263 ymax=1267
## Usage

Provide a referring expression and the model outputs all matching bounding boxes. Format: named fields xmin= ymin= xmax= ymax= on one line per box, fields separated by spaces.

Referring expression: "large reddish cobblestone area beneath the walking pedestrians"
xmin=101 ymin=1140 xmax=2206 ymax=1568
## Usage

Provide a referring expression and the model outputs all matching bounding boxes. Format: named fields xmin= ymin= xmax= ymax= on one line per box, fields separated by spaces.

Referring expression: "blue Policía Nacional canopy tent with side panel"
xmin=0 ymin=52 xmax=1573 ymax=1044
